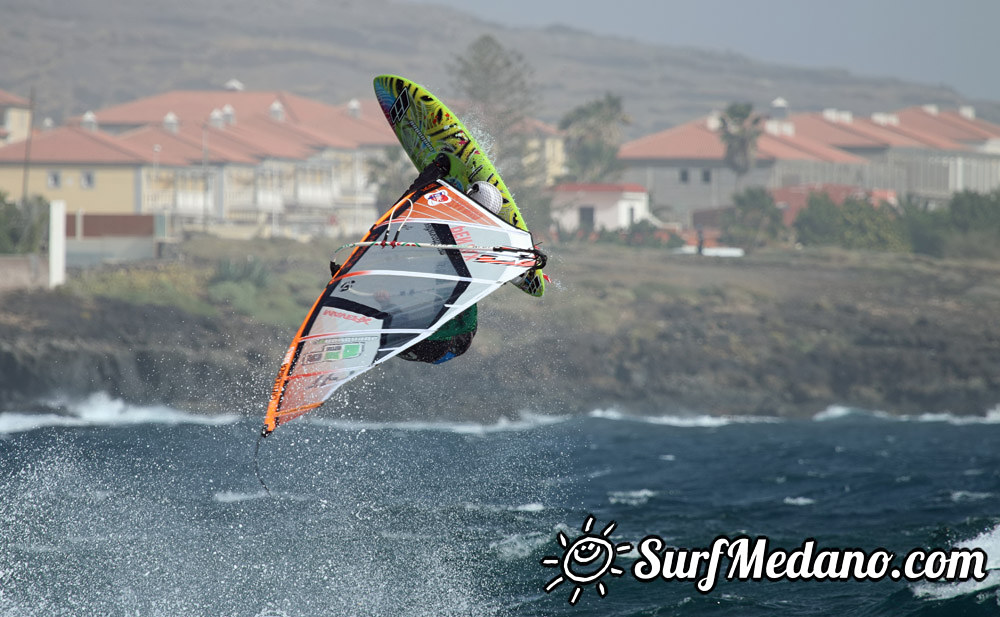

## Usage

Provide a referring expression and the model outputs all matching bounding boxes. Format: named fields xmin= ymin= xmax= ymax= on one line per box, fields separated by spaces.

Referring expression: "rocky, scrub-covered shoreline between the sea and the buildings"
xmin=0 ymin=246 xmax=1000 ymax=421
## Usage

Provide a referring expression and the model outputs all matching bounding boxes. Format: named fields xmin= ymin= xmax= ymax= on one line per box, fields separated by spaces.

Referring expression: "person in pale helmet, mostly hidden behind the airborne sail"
xmin=330 ymin=152 xmax=503 ymax=364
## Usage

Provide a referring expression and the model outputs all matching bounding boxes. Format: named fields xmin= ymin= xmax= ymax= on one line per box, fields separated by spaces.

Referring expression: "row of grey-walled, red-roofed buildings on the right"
xmin=619 ymin=101 xmax=1000 ymax=223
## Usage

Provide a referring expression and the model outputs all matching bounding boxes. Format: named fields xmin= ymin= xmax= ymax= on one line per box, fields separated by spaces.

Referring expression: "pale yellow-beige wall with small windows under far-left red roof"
xmin=0 ymin=163 xmax=138 ymax=214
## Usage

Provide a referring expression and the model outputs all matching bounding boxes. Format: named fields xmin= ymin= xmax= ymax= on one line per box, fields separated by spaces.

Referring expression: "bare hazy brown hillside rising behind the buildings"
xmin=0 ymin=0 xmax=1000 ymax=137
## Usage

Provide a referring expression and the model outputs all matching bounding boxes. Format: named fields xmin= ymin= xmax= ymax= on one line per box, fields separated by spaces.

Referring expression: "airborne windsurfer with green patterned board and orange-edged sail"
xmin=261 ymin=75 xmax=546 ymax=436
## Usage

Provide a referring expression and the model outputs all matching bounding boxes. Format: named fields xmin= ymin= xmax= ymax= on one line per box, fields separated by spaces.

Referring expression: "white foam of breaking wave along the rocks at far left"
xmin=0 ymin=392 xmax=240 ymax=433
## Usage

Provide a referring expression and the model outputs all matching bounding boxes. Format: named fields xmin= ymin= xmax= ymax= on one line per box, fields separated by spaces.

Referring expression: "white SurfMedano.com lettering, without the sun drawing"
xmin=632 ymin=536 xmax=987 ymax=594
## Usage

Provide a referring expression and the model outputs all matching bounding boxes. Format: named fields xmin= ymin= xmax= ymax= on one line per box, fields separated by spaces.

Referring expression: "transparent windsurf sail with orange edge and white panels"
xmin=261 ymin=182 xmax=544 ymax=436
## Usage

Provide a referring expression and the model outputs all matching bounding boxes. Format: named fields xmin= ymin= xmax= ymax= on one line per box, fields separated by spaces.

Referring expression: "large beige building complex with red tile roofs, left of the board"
xmin=0 ymin=90 xmax=406 ymax=231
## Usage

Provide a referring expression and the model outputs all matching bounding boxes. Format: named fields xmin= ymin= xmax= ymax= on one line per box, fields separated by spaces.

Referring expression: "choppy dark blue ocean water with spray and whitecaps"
xmin=0 ymin=395 xmax=1000 ymax=617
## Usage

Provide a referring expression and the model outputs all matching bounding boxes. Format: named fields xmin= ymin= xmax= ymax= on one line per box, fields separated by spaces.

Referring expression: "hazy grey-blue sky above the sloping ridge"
xmin=408 ymin=0 xmax=1000 ymax=100
